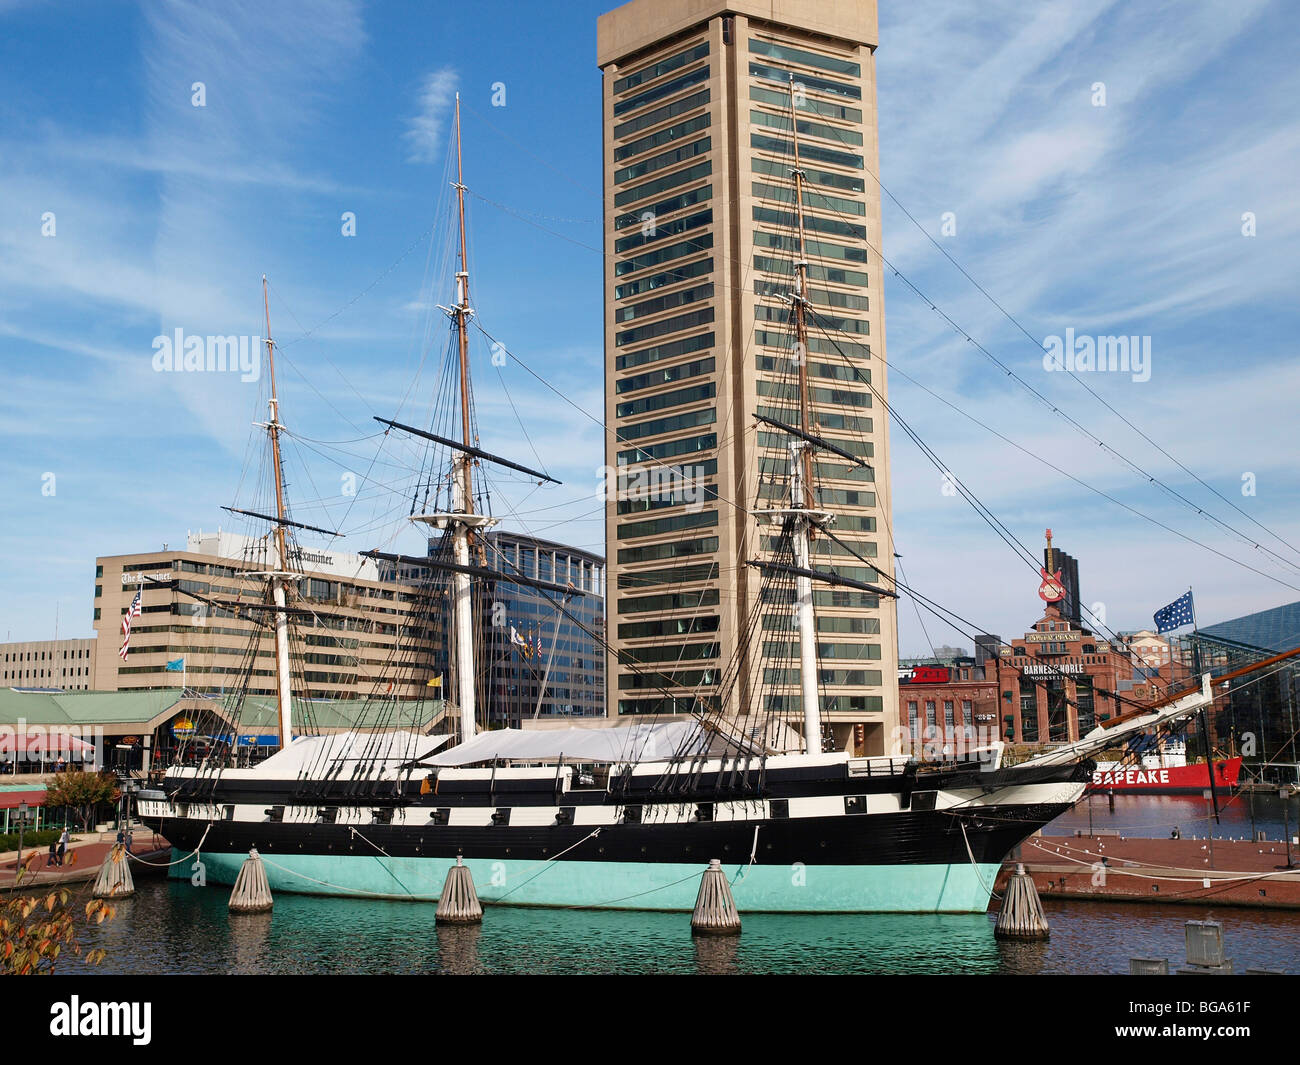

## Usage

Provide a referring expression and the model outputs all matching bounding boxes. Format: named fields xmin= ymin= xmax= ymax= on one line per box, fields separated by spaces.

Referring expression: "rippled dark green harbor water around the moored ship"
xmin=64 ymin=795 xmax=1300 ymax=975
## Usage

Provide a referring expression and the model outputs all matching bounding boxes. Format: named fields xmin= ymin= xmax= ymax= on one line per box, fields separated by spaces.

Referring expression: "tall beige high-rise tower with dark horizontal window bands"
xmin=598 ymin=0 xmax=898 ymax=753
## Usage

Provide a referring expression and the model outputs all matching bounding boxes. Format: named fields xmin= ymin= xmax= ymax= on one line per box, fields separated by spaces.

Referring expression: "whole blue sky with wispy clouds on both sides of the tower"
xmin=0 ymin=0 xmax=1300 ymax=654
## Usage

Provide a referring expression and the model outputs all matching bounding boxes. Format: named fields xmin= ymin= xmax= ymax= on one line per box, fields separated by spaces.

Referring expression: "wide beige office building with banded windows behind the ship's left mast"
xmin=92 ymin=532 xmax=442 ymax=700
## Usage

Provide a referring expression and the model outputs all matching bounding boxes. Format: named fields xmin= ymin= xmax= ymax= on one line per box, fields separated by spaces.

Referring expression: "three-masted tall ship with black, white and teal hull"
xmin=139 ymin=95 xmax=1210 ymax=913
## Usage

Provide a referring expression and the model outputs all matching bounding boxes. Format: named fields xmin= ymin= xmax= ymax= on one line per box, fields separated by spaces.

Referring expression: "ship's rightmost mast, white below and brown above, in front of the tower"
xmin=787 ymin=74 xmax=829 ymax=754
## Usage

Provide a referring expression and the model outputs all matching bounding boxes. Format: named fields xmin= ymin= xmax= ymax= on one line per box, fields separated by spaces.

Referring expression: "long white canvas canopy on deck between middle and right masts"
xmin=424 ymin=720 xmax=707 ymax=766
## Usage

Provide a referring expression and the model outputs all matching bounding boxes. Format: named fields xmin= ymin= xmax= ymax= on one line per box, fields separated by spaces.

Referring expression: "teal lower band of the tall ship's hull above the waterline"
xmin=170 ymin=850 xmax=998 ymax=913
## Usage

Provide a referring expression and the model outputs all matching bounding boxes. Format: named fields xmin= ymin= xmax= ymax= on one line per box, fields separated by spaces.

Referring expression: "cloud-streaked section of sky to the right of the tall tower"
xmin=878 ymin=0 xmax=1300 ymax=653
